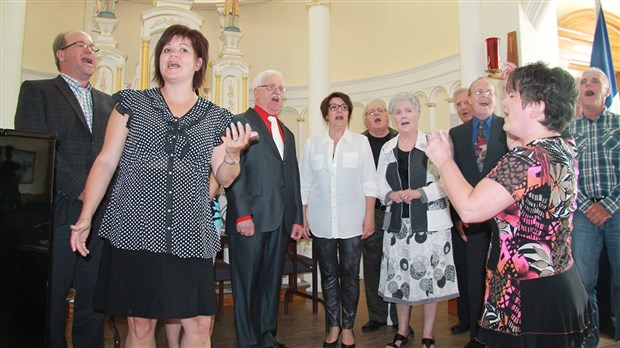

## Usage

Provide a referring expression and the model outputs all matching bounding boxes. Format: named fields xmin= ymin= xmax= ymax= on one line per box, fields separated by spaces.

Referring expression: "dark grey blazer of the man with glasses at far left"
xmin=15 ymin=75 xmax=113 ymax=225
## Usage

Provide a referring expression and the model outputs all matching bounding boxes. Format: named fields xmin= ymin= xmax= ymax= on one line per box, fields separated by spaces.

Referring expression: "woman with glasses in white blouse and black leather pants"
xmin=300 ymin=92 xmax=378 ymax=347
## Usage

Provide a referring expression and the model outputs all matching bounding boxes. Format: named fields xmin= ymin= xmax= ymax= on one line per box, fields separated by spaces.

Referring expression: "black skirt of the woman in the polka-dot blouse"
xmin=93 ymin=240 xmax=217 ymax=319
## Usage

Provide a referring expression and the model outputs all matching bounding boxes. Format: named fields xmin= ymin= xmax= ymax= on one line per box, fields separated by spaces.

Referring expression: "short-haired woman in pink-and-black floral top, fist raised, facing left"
xmin=426 ymin=62 xmax=590 ymax=348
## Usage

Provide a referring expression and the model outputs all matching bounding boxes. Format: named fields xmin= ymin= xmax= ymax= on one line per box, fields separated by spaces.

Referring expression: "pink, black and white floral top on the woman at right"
xmin=482 ymin=136 xmax=578 ymax=334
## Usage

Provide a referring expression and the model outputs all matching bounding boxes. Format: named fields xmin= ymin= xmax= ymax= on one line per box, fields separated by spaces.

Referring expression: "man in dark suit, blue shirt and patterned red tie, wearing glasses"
xmin=450 ymin=77 xmax=508 ymax=348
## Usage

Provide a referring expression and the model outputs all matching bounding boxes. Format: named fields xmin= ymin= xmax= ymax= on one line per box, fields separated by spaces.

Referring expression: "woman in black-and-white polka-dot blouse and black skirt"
xmin=70 ymin=25 xmax=252 ymax=347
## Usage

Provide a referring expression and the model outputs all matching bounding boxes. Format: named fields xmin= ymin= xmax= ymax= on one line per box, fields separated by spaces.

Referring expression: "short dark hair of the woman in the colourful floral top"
xmin=506 ymin=62 xmax=579 ymax=133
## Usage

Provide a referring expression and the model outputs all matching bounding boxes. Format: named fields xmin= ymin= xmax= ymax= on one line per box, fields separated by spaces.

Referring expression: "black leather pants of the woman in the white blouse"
xmin=313 ymin=236 xmax=362 ymax=330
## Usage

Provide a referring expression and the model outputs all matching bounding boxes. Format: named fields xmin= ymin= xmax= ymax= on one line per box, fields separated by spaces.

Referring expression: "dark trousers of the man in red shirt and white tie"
xmin=228 ymin=226 xmax=290 ymax=347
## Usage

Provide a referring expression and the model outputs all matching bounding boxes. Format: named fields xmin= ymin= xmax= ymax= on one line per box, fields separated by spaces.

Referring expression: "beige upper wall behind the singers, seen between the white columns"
xmin=23 ymin=0 xmax=458 ymax=86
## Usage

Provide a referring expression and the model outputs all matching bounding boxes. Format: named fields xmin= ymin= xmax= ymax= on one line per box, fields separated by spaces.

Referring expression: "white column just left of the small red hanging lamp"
xmin=458 ymin=1 xmax=486 ymax=88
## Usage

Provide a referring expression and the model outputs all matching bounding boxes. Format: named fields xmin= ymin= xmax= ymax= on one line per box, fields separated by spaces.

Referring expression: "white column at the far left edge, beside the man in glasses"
xmin=0 ymin=1 xmax=26 ymax=128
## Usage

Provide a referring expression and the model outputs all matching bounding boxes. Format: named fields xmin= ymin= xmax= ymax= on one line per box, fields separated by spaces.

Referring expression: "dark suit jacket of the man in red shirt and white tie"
xmin=226 ymin=108 xmax=303 ymax=234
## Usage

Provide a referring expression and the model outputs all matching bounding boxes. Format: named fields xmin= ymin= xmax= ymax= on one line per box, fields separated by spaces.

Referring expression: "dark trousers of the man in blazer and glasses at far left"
xmin=48 ymin=222 xmax=103 ymax=348
